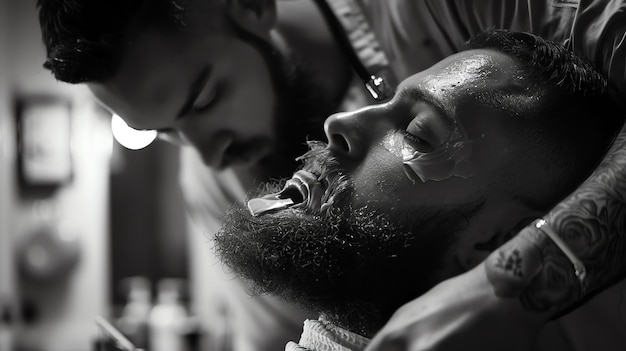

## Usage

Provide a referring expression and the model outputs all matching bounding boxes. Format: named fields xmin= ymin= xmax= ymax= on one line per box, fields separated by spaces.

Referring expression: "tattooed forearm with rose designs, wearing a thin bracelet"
xmin=485 ymin=129 xmax=626 ymax=315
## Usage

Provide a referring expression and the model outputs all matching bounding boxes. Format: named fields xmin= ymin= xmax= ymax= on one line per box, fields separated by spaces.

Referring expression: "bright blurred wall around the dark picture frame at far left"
xmin=0 ymin=0 xmax=112 ymax=351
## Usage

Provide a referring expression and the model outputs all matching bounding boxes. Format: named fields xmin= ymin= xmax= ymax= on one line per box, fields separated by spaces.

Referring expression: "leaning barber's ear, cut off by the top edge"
xmin=225 ymin=0 xmax=276 ymax=36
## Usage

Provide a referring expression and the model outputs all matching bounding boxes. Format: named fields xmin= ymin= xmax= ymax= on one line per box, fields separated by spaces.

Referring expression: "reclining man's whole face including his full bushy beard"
xmin=216 ymin=50 xmax=544 ymax=333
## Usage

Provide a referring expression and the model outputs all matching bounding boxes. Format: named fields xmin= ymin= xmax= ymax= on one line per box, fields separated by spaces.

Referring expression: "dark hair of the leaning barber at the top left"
xmin=37 ymin=0 xmax=185 ymax=83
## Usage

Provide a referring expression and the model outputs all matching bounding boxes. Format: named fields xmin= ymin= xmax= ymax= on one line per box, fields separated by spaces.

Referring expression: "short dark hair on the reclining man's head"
xmin=467 ymin=30 xmax=626 ymax=208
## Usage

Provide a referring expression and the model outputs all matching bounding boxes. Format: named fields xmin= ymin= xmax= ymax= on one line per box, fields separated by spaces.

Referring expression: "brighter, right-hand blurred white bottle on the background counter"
xmin=148 ymin=278 xmax=189 ymax=351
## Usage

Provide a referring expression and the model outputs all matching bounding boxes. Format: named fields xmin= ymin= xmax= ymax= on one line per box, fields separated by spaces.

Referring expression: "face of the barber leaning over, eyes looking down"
xmin=89 ymin=1 xmax=330 ymax=168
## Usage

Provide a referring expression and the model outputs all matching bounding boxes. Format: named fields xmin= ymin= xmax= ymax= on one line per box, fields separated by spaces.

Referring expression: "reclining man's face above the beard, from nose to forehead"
xmin=325 ymin=50 xmax=545 ymax=213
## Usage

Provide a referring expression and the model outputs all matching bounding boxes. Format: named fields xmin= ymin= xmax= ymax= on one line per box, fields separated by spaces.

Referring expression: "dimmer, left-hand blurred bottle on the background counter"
xmin=117 ymin=276 xmax=152 ymax=348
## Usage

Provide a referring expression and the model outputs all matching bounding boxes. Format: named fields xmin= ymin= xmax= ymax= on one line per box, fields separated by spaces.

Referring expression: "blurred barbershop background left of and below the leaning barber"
xmin=0 ymin=0 xmax=213 ymax=351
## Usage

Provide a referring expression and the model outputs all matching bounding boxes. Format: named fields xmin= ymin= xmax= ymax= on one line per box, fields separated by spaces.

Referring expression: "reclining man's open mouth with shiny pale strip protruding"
xmin=248 ymin=170 xmax=326 ymax=216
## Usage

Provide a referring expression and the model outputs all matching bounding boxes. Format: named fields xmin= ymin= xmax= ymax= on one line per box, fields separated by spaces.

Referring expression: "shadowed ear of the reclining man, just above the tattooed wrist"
xmin=454 ymin=199 xmax=544 ymax=271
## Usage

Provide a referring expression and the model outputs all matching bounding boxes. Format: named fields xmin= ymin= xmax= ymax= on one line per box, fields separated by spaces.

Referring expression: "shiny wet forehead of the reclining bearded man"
xmin=398 ymin=49 xmax=550 ymax=139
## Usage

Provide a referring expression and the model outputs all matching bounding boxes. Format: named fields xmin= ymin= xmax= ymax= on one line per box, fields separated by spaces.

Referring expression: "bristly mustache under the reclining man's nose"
xmin=296 ymin=140 xmax=353 ymax=210
